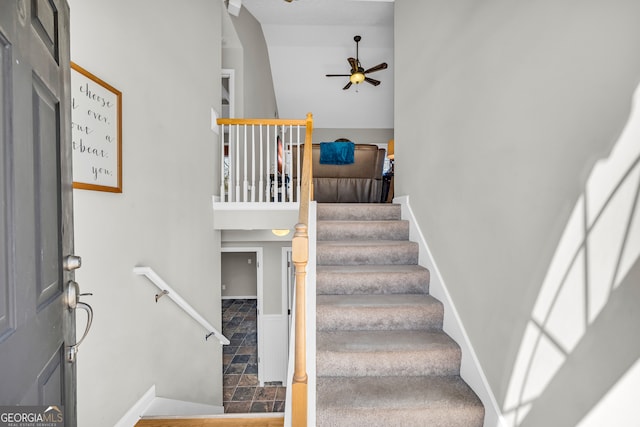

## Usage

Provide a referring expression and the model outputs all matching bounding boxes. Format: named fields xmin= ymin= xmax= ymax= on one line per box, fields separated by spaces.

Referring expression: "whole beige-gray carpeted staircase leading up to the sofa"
xmin=316 ymin=204 xmax=484 ymax=427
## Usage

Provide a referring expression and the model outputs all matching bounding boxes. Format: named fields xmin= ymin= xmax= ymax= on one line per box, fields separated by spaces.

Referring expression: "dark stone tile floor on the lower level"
xmin=222 ymin=299 xmax=286 ymax=413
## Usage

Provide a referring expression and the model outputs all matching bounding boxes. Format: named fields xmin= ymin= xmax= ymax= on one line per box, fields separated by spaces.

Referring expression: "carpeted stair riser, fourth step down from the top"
xmin=316 ymin=270 xmax=429 ymax=295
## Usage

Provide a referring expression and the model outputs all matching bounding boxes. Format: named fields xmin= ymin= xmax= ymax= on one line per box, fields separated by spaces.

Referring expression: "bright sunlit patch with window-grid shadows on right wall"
xmin=503 ymin=82 xmax=640 ymax=427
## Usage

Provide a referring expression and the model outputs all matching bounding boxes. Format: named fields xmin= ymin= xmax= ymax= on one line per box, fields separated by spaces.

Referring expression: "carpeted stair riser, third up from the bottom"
xmin=316 ymin=304 xmax=443 ymax=331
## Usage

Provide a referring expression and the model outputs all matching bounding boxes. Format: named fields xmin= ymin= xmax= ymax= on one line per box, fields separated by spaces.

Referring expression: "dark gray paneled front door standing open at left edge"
xmin=0 ymin=0 xmax=76 ymax=426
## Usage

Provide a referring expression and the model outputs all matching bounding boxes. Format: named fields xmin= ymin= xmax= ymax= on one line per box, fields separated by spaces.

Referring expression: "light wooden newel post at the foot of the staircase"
xmin=291 ymin=223 xmax=309 ymax=427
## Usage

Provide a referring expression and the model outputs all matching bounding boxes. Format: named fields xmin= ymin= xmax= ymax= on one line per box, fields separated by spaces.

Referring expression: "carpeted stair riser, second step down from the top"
xmin=316 ymin=221 xmax=409 ymax=241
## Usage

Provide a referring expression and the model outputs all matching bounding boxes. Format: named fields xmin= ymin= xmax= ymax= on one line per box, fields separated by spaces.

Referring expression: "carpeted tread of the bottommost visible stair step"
xmin=317 ymin=375 xmax=482 ymax=410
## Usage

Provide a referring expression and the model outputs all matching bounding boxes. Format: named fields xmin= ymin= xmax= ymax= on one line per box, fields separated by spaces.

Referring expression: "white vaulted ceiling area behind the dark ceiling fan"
xmin=242 ymin=0 xmax=394 ymax=129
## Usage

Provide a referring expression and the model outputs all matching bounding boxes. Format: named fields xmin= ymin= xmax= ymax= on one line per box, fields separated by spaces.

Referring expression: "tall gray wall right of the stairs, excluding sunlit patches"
xmin=395 ymin=0 xmax=640 ymax=426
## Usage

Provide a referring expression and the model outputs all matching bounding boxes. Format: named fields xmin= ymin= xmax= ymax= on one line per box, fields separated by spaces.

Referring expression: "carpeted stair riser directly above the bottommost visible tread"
xmin=316 ymin=347 xmax=460 ymax=377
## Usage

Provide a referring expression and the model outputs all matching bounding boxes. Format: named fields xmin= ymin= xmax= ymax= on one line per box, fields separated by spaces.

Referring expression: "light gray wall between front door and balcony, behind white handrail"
xmin=69 ymin=0 xmax=222 ymax=427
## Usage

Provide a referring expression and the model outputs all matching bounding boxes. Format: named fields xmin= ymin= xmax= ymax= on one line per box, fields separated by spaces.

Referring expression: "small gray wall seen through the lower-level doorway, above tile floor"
xmin=220 ymin=252 xmax=258 ymax=298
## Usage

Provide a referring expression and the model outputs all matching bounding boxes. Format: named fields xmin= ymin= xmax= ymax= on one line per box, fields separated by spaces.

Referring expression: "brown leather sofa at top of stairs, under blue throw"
xmin=292 ymin=144 xmax=385 ymax=203
